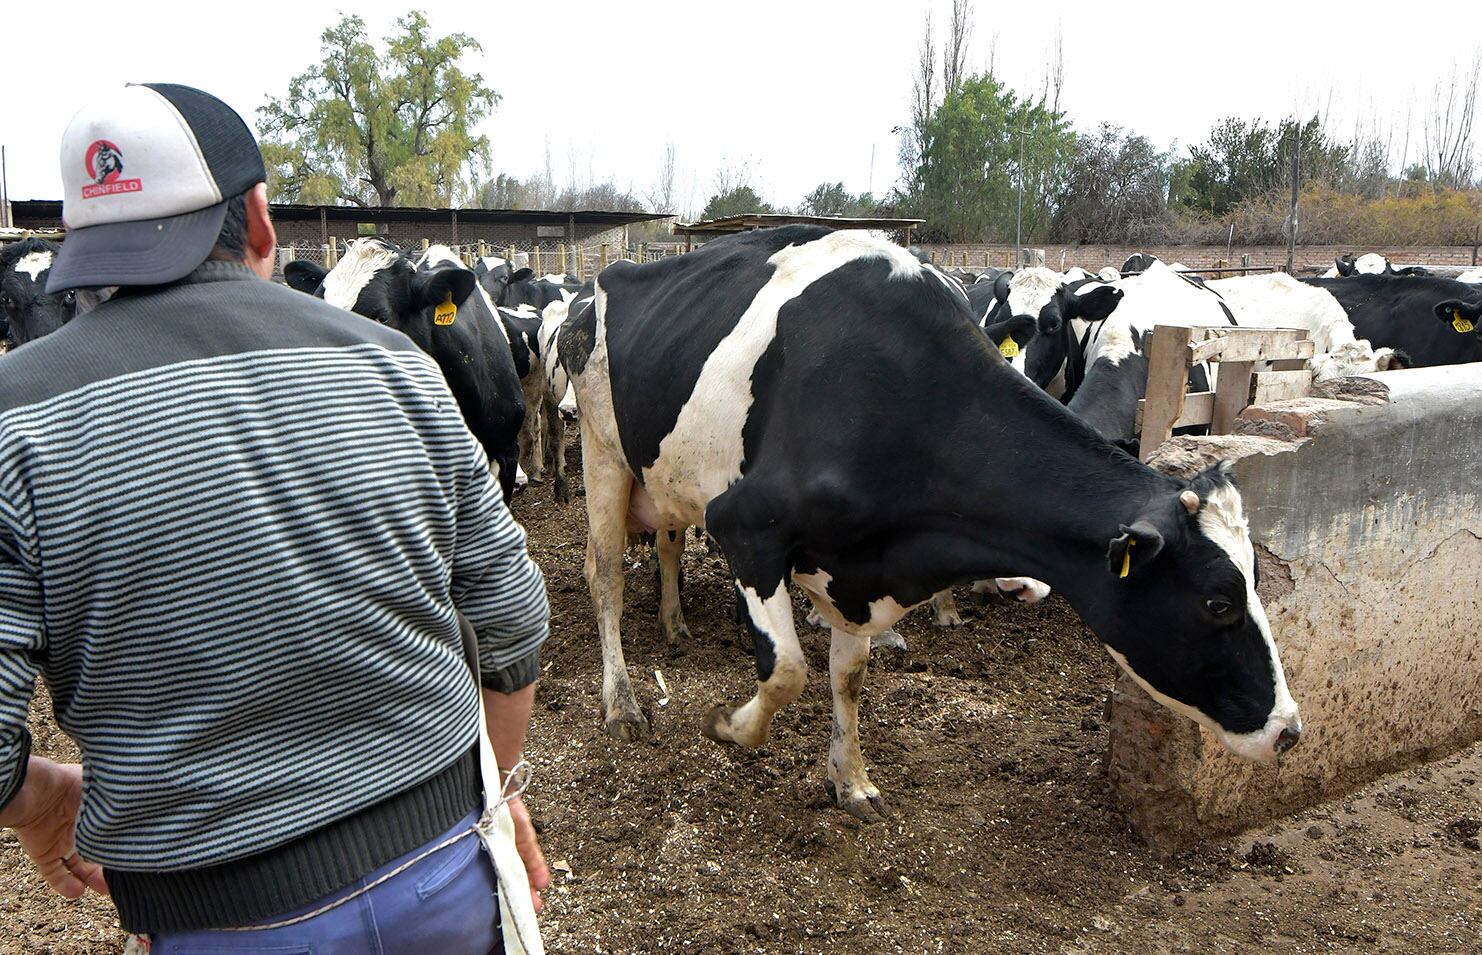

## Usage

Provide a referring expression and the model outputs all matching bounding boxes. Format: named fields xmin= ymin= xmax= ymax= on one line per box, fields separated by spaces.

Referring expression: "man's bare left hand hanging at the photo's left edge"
xmin=4 ymin=756 xmax=108 ymax=899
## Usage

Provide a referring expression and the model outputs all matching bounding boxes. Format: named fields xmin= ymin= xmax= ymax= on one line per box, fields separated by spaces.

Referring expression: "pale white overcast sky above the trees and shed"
xmin=0 ymin=0 xmax=1482 ymax=209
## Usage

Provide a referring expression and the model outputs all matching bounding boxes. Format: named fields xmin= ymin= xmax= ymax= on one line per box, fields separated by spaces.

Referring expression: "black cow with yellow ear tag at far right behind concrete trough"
xmin=1304 ymin=274 xmax=1482 ymax=368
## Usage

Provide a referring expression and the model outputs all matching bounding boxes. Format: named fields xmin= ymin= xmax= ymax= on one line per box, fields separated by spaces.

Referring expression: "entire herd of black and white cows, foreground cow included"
xmin=0 ymin=227 xmax=1482 ymax=820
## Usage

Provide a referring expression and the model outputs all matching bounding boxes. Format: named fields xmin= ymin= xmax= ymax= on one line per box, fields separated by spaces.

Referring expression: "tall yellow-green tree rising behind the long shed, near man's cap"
xmin=258 ymin=12 xmax=498 ymax=206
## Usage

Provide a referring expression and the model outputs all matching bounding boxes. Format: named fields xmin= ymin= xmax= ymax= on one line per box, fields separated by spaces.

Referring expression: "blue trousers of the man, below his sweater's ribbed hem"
xmin=150 ymin=814 xmax=504 ymax=955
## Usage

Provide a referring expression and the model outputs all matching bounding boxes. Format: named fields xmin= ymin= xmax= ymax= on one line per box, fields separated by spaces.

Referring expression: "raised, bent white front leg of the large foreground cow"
xmin=702 ymin=583 xmax=808 ymax=746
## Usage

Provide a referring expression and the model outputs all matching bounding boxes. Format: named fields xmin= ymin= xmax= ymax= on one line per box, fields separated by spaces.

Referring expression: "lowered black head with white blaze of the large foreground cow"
xmin=1088 ymin=466 xmax=1301 ymax=762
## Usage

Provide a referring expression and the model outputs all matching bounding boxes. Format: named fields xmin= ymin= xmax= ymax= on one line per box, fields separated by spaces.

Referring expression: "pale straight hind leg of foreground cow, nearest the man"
xmin=581 ymin=434 xmax=649 ymax=741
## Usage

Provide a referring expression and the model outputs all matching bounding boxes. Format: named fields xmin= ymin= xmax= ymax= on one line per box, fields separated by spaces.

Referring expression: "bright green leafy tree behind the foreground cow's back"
xmin=897 ymin=76 xmax=1076 ymax=242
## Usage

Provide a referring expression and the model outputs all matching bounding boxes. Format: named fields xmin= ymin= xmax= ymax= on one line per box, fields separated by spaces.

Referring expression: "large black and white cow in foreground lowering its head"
xmin=559 ymin=227 xmax=1300 ymax=820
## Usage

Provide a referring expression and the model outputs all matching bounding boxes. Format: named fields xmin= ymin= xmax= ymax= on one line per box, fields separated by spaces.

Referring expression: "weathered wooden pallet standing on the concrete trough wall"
xmin=1137 ymin=325 xmax=1313 ymax=461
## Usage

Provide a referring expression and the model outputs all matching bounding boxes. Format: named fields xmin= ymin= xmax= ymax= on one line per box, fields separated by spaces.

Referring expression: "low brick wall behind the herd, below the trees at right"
xmin=920 ymin=243 xmax=1478 ymax=274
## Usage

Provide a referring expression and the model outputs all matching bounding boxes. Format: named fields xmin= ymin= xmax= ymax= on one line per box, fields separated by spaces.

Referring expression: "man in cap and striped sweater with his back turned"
xmin=0 ymin=85 xmax=550 ymax=955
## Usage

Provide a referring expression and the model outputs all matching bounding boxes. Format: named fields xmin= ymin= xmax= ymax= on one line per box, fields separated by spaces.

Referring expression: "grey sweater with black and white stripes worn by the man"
xmin=0 ymin=262 xmax=548 ymax=930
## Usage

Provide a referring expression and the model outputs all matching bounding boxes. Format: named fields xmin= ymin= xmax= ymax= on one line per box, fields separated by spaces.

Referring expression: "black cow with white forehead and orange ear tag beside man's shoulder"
xmin=283 ymin=239 xmax=525 ymax=501
